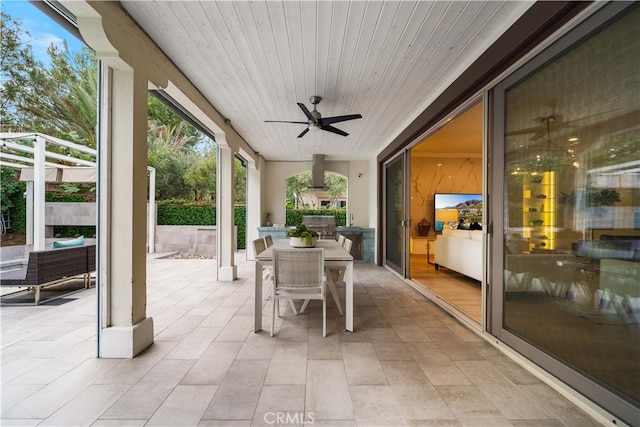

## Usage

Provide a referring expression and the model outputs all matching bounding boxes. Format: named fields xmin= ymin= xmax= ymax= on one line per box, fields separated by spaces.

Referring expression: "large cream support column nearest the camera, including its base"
xmin=100 ymin=69 xmax=153 ymax=358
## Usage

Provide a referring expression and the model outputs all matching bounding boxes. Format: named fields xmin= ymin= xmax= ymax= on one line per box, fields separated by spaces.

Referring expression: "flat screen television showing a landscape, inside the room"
xmin=434 ymin=193 xmax=482 ymax=231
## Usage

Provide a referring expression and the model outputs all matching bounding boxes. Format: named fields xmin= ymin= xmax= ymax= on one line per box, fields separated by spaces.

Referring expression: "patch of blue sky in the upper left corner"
xmin=1 ymin=0 xmax=83 ymax=66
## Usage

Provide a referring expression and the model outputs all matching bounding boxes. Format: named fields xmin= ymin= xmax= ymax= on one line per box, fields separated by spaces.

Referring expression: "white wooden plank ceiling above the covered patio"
xmin=122 ymin=1 xmax=532 ymax=161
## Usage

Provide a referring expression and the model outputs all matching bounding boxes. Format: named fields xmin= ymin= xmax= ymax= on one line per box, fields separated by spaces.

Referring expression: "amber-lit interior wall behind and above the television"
xmin=410 ymin=154 xmax=482 ymax=237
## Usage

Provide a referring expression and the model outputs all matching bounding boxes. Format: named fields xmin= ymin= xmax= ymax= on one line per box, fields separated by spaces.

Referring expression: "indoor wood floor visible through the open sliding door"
xmin=411 ymin=255 xmax=482 ymax=325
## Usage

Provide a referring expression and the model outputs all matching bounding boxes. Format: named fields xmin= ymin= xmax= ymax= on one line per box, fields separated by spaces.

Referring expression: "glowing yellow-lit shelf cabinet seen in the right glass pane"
xmin=522 ymin=172 xmax=557 ymax=250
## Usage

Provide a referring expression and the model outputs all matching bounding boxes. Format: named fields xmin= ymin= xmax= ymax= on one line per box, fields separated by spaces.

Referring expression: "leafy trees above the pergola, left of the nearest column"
xmin=0 ymin=13 xmax=98 ymax=147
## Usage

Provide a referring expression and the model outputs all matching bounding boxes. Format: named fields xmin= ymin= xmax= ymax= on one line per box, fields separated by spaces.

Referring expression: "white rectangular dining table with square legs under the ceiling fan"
xmin=254 ymin=239 xmax=353 ymax=332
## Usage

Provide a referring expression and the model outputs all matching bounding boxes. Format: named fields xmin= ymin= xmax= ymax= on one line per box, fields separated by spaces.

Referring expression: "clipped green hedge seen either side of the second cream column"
xmin=157 ymin=202 xmax=247 ymax=249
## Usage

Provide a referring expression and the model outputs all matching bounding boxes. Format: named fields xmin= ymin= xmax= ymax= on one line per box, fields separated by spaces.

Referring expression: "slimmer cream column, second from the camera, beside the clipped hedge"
xmin=216 ymin=144 xmax=238 ymax=282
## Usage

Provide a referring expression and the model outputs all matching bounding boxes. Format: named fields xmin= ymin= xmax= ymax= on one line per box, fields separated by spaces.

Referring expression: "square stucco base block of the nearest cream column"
xmin=100 ymin=317 xmax=153 ymax=359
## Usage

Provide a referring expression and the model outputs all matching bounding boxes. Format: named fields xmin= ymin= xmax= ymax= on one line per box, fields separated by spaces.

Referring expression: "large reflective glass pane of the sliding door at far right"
xmin=503 ymin=8 xmax=640 ymax=406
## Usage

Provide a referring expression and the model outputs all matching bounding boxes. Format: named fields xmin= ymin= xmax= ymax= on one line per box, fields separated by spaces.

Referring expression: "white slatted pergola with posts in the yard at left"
xmin=0 ymin=132 xmax=156 ymax=252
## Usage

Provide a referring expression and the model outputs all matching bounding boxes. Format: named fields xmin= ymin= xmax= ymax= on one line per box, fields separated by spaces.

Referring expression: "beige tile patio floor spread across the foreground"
xmin=0 ymin=253 xmax=599 ymax=427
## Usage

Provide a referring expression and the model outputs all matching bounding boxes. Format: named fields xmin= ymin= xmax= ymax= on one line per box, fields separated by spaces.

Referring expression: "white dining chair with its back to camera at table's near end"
xmin=271 ymin=248 xmax=327 ymax=337
